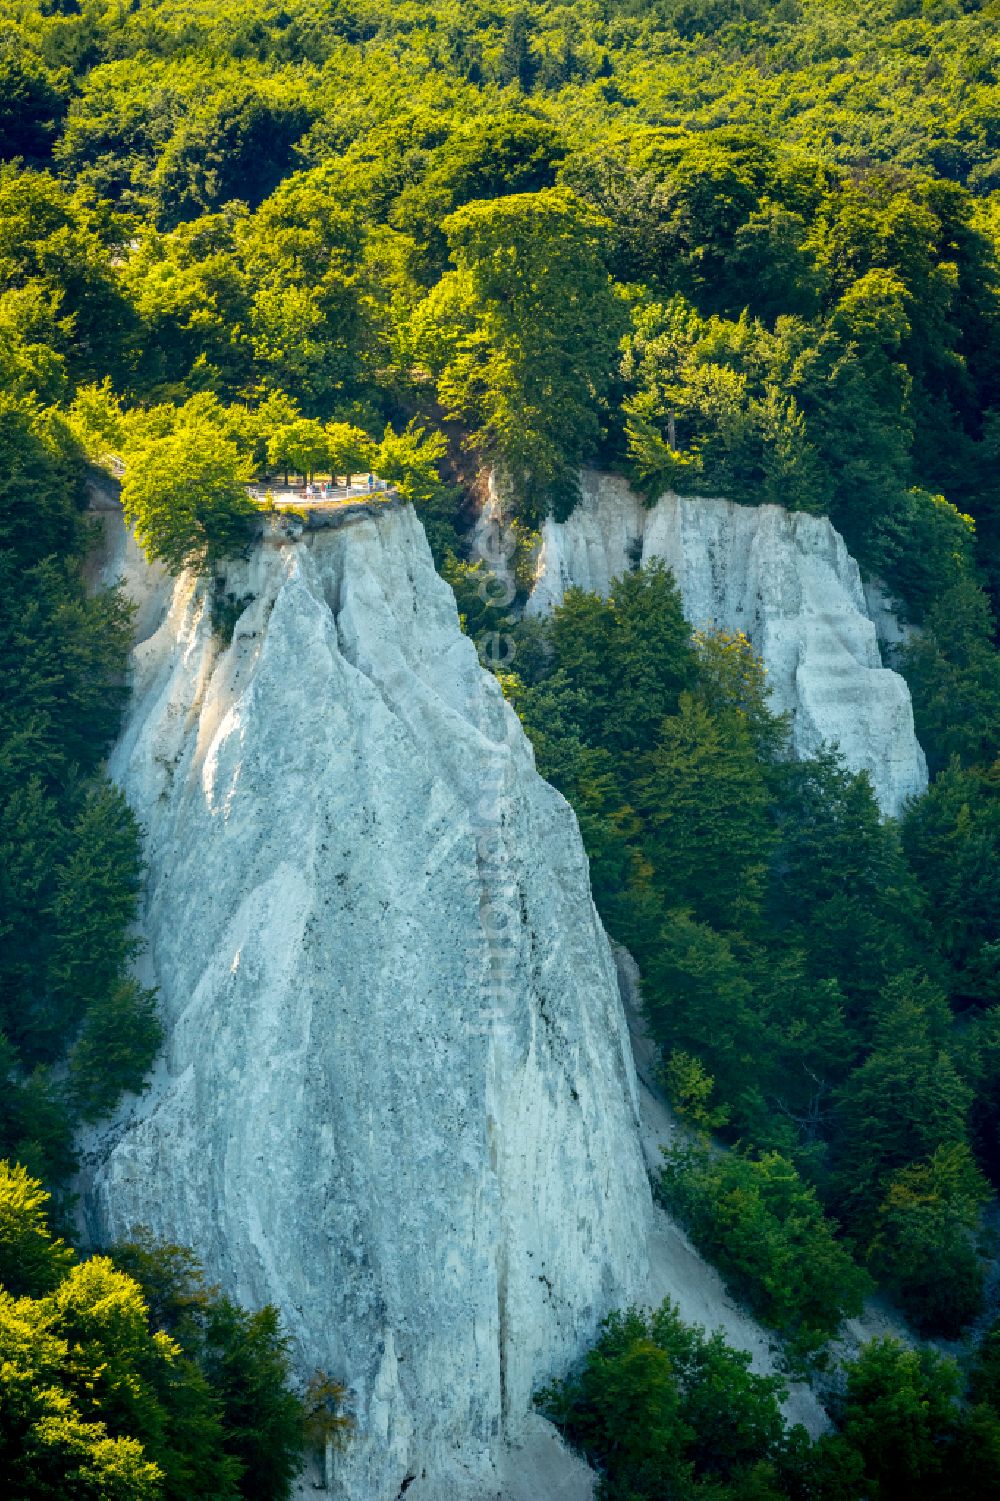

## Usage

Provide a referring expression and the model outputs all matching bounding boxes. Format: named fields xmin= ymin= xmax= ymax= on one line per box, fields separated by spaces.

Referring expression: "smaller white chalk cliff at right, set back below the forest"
xmin=527 ymin=473 xmax=926 ymax=814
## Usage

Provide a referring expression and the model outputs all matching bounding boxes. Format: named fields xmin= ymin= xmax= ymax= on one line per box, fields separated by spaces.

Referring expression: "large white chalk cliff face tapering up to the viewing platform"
xmin=81 ymin=506 xmax=650 ymax=1501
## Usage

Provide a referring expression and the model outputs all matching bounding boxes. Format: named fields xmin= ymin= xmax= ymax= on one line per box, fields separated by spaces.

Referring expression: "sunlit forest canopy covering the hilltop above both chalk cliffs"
xmin=0 ymin=0 xmax=1000 ymax=614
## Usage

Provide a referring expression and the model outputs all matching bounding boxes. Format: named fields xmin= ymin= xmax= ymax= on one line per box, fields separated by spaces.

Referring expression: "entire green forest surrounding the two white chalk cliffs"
xmin=0 ymin=0 xmax=1000 ymax=1501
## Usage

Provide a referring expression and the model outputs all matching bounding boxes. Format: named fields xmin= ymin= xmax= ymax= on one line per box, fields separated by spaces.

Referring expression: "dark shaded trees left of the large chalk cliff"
xmin=0 ymin=396 xmax=159 ymax=1183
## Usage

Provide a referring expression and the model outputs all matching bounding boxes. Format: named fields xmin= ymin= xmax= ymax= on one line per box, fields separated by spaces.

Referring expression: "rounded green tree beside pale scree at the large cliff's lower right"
xmin=659 ymin=1145 xmax=869 ymax=1355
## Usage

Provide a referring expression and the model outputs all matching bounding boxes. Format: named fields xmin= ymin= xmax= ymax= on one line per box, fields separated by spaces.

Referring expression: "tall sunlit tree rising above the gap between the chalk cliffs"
xmin=417 ymin=188 xmax=623 ymax=515
